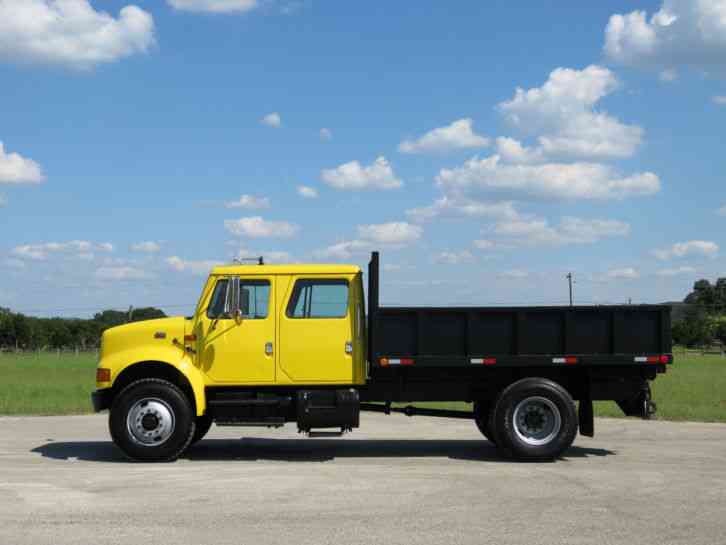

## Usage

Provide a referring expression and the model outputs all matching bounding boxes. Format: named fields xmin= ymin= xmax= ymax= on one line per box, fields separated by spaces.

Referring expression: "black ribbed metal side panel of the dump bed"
xmin=371 ymin=305 xmax=671 ymax=366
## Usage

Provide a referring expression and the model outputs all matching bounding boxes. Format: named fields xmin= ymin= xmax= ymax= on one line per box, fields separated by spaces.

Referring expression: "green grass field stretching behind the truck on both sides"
xmin=0 ymin=353 xmax=726 ymax=422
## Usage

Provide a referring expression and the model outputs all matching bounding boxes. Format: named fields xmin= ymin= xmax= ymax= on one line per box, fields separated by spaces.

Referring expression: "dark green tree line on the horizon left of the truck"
xmin=0 ymin=307 xmax=166 ymax=350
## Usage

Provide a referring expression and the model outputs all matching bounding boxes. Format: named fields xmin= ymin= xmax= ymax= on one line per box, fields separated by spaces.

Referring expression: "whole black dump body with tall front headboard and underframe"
xmin=364 ymin=252 xmax=673 ymax=401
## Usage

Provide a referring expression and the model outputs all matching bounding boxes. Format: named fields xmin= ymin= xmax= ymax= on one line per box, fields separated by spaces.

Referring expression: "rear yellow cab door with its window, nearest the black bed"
xmin=279 ymin=275 xmax=356 ymax=384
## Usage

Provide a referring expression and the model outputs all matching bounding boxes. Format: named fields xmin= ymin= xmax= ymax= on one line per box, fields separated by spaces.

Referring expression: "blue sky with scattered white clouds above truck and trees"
xmin=0 ymin=0 xmax=726 ymax=316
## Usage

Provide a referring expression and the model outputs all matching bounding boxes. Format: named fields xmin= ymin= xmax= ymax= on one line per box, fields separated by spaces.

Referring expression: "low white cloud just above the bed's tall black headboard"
xmin=314 ymin=222 xmax=423 ymax=259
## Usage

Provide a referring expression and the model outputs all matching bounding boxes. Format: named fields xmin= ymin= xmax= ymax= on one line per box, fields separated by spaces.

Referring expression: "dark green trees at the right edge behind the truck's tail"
xmin=672 ymin=278 xmax=726 ymax=347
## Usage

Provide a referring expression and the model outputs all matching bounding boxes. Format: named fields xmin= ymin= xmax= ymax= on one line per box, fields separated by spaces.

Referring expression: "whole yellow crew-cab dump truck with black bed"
xmin=92 ymin=252 xmax=673 ymax=461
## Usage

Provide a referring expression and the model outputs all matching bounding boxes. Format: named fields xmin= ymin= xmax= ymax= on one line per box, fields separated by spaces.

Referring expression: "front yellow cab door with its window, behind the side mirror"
xmin=195 ymin=275 xmax=277 ymax=385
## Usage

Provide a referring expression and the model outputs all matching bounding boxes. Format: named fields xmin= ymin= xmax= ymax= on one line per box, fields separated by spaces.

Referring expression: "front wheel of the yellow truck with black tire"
xmin=108 ymin=378 xmax=196 ymax=462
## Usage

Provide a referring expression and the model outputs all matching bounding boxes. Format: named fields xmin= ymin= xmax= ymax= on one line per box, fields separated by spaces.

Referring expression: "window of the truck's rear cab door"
xmin=287 ymin=279 xmax=348 ymax=318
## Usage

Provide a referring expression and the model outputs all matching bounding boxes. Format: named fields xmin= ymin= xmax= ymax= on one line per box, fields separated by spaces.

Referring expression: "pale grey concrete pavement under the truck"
xmin=0 ymin=413 xmax=726 ymax=545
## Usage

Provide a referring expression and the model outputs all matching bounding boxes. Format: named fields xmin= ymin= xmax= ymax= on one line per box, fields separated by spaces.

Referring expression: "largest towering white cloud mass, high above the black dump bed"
xmin=416 ymin=65 xmax=661 ymax=222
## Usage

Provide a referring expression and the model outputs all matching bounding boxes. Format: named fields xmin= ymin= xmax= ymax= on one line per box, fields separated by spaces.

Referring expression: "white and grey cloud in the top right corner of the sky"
xmin=604 ymin=0 xmax=726 ymax=72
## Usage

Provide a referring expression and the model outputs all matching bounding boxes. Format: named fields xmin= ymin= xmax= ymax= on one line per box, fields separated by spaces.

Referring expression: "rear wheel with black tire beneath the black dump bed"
xmin=489 ymin=378 xmax=578 ymax=461
